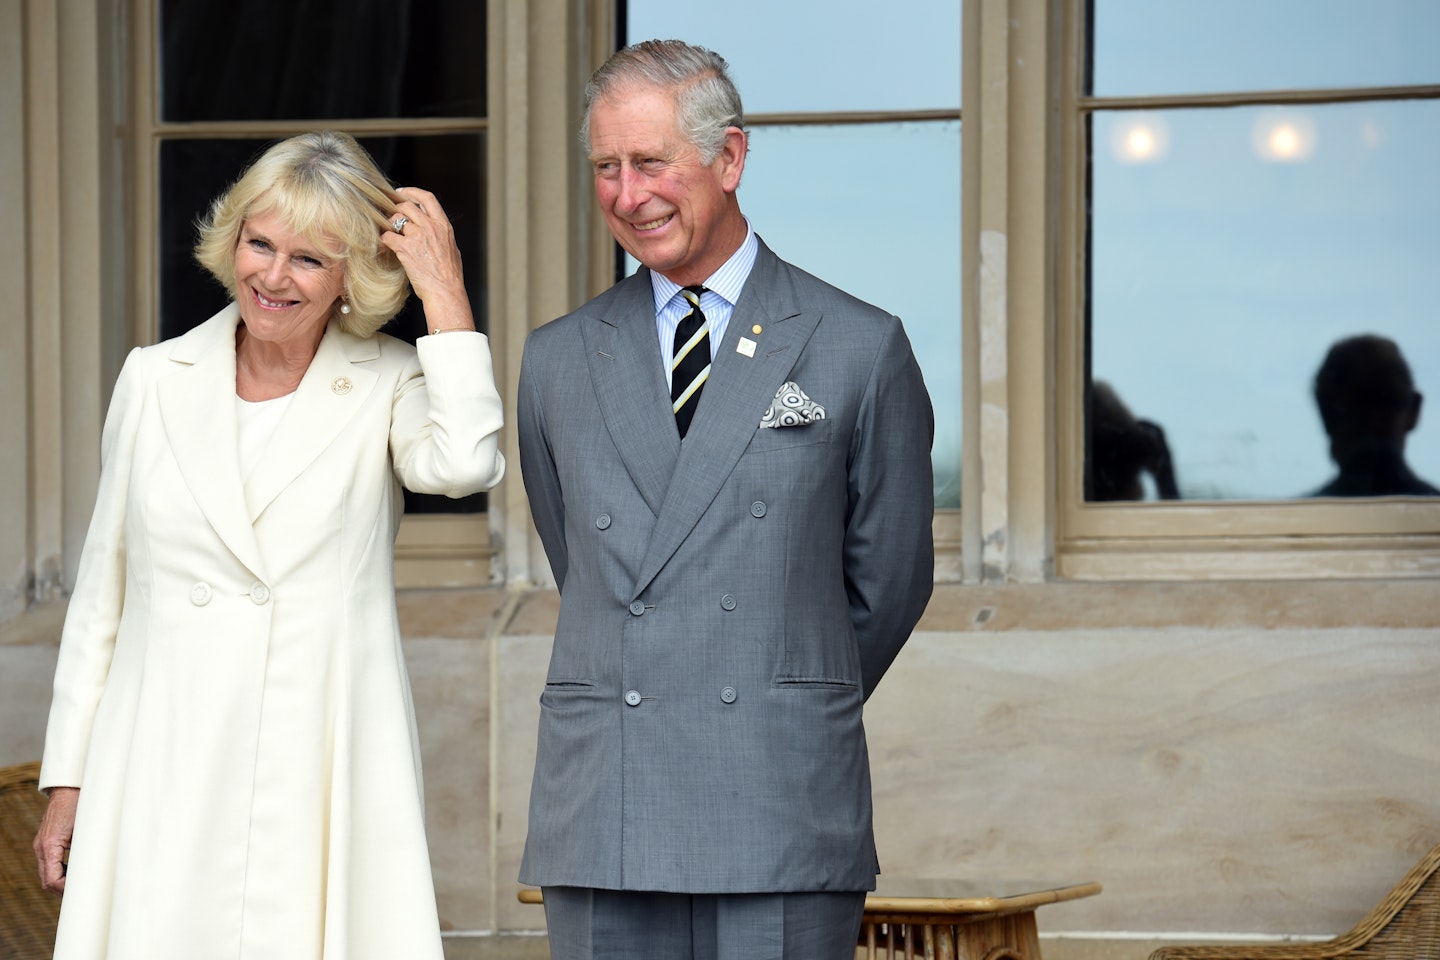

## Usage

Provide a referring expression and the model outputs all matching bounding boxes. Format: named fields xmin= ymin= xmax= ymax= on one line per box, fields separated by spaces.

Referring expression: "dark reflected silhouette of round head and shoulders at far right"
xmin=1310 ymin=334 xmax=1440 ymax=497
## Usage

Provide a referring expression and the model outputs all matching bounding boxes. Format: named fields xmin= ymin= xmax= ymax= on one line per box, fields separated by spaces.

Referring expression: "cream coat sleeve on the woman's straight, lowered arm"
xmin=40 ymin=348 xmax=145 ymax=790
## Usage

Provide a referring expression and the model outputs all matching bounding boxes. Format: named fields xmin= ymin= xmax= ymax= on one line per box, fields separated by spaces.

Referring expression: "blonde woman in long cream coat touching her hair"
xmin=35 ymin=132 xmax=504 ymax=960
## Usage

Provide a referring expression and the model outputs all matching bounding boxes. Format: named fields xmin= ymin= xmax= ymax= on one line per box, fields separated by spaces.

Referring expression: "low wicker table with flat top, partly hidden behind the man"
xmin=520 ymin=877 xmax=1100 ymax=960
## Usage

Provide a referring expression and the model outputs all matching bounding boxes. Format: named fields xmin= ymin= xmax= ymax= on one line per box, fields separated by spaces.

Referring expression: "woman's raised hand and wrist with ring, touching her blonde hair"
xmin=380 ymin=187 xmax=475 ymax=332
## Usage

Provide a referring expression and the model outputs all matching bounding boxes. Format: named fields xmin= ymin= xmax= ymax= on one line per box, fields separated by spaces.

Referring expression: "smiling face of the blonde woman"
xmin=235 ymin=214 xmax=346 ymax=343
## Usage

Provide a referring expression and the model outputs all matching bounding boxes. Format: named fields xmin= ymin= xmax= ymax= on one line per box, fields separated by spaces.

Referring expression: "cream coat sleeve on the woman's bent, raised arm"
xmin=390 ymin=331 xmax=505 ymax=497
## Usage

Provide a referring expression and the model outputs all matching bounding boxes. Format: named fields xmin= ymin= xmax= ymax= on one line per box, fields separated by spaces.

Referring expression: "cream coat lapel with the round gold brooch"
xmin=245 ymin=324 xmax=380 ymax=522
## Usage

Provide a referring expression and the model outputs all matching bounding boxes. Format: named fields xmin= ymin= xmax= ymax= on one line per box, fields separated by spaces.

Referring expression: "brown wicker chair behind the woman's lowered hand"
xmin=0 ymin=763 xmax=60 ymax=960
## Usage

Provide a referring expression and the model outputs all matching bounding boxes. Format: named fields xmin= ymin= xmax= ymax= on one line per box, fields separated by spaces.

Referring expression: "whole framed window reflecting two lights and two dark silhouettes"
xmin=1057 ymin=0 xmax=1440 ymax=577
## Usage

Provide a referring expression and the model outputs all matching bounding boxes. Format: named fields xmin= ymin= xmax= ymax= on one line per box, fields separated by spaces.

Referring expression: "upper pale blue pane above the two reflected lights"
xmin=1092 ymin=0 xmax=1440 ymax=96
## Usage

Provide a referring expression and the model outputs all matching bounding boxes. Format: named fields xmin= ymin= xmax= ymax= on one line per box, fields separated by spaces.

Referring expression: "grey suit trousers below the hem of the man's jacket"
xmin=544 ymin=887 xmax=865 ymax=960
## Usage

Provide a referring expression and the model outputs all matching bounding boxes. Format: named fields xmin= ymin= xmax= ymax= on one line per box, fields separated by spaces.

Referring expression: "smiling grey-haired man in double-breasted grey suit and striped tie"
xmin=517 ymin=40 xmax=933 ymax=960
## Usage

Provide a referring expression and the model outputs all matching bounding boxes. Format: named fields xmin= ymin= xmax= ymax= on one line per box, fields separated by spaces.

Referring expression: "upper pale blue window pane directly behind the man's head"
xmin=625 ymin=0 xmax=960 ymax=114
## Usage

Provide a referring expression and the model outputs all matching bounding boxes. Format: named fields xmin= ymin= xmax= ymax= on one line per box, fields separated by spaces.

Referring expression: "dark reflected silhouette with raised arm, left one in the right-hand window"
xmin=1086 ymin=380 xmax=1179 ymax=501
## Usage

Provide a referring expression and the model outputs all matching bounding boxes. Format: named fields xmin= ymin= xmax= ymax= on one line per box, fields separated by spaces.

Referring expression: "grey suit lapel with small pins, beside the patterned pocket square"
xmin=635 ymin=243 xmax=821 ymax=596
